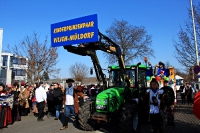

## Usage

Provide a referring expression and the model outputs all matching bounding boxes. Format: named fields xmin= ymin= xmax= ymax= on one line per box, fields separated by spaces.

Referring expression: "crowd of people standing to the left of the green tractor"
xmin=0 ymin=79 xmax=101 ymax=130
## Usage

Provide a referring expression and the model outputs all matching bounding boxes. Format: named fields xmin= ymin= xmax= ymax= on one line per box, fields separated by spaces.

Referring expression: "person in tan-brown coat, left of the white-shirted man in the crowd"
xmin=19 ymin=86 xmax=30 ymax=116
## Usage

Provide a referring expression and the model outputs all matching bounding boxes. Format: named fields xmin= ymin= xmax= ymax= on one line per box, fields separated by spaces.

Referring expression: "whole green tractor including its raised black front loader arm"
xmin=64 ymin=32 xmax=148 ymax=133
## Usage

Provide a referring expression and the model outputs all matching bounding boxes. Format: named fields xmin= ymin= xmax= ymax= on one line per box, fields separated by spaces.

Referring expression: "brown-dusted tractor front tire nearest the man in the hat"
xmin=78 ymin=101 xmax=94 ymax=131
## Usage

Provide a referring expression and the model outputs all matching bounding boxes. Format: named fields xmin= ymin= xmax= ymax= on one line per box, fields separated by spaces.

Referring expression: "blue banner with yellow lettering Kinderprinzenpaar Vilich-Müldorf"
xmin=51 ymin=14 xmax=98 ymax=47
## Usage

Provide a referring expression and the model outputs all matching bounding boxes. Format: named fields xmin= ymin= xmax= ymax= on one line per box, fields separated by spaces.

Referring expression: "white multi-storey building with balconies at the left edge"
xmin=0 ymin=52 xmax=28 ymax=85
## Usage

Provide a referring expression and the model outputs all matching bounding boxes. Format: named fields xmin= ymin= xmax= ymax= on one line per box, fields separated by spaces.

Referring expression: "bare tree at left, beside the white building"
xmin=8 ymin=32 xmax=60 ymax=82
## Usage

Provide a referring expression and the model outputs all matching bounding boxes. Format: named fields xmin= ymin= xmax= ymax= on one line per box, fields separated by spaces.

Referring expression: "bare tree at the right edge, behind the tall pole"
xmin=173 ymin=3 xmax=200 ymax=70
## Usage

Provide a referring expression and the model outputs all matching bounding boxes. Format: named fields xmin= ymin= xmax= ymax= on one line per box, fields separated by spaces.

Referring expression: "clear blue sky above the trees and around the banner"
xmin=0 ymin=0 xmax=200 ymax=78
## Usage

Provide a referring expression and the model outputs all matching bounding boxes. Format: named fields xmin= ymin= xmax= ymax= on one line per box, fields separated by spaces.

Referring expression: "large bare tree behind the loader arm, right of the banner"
xmin=104 ymin=20 xmax=154 ymax=64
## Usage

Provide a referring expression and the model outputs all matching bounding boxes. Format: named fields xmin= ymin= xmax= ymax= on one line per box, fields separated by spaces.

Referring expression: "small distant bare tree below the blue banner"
xmin=69 ymin=62 xmax=89 ymax=81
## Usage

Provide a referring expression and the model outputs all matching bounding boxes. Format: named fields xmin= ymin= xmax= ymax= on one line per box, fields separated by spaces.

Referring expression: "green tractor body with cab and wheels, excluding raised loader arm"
xmin=76 ymin=64 xmax=148 ymax=133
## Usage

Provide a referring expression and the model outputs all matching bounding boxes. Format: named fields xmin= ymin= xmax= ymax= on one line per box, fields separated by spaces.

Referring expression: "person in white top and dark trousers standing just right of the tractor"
xmin=146 ymin=78 xmax=164 ymax=133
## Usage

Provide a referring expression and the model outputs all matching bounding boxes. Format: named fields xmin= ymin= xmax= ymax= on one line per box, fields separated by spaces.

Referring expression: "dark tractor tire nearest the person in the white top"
xmin=119 ymin=103 xmax=138 ymax=133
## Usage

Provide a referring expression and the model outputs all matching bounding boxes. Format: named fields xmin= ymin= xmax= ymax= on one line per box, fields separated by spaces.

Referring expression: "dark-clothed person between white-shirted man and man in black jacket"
xmin=47 ymin=84 xmax=54 ymax=117
